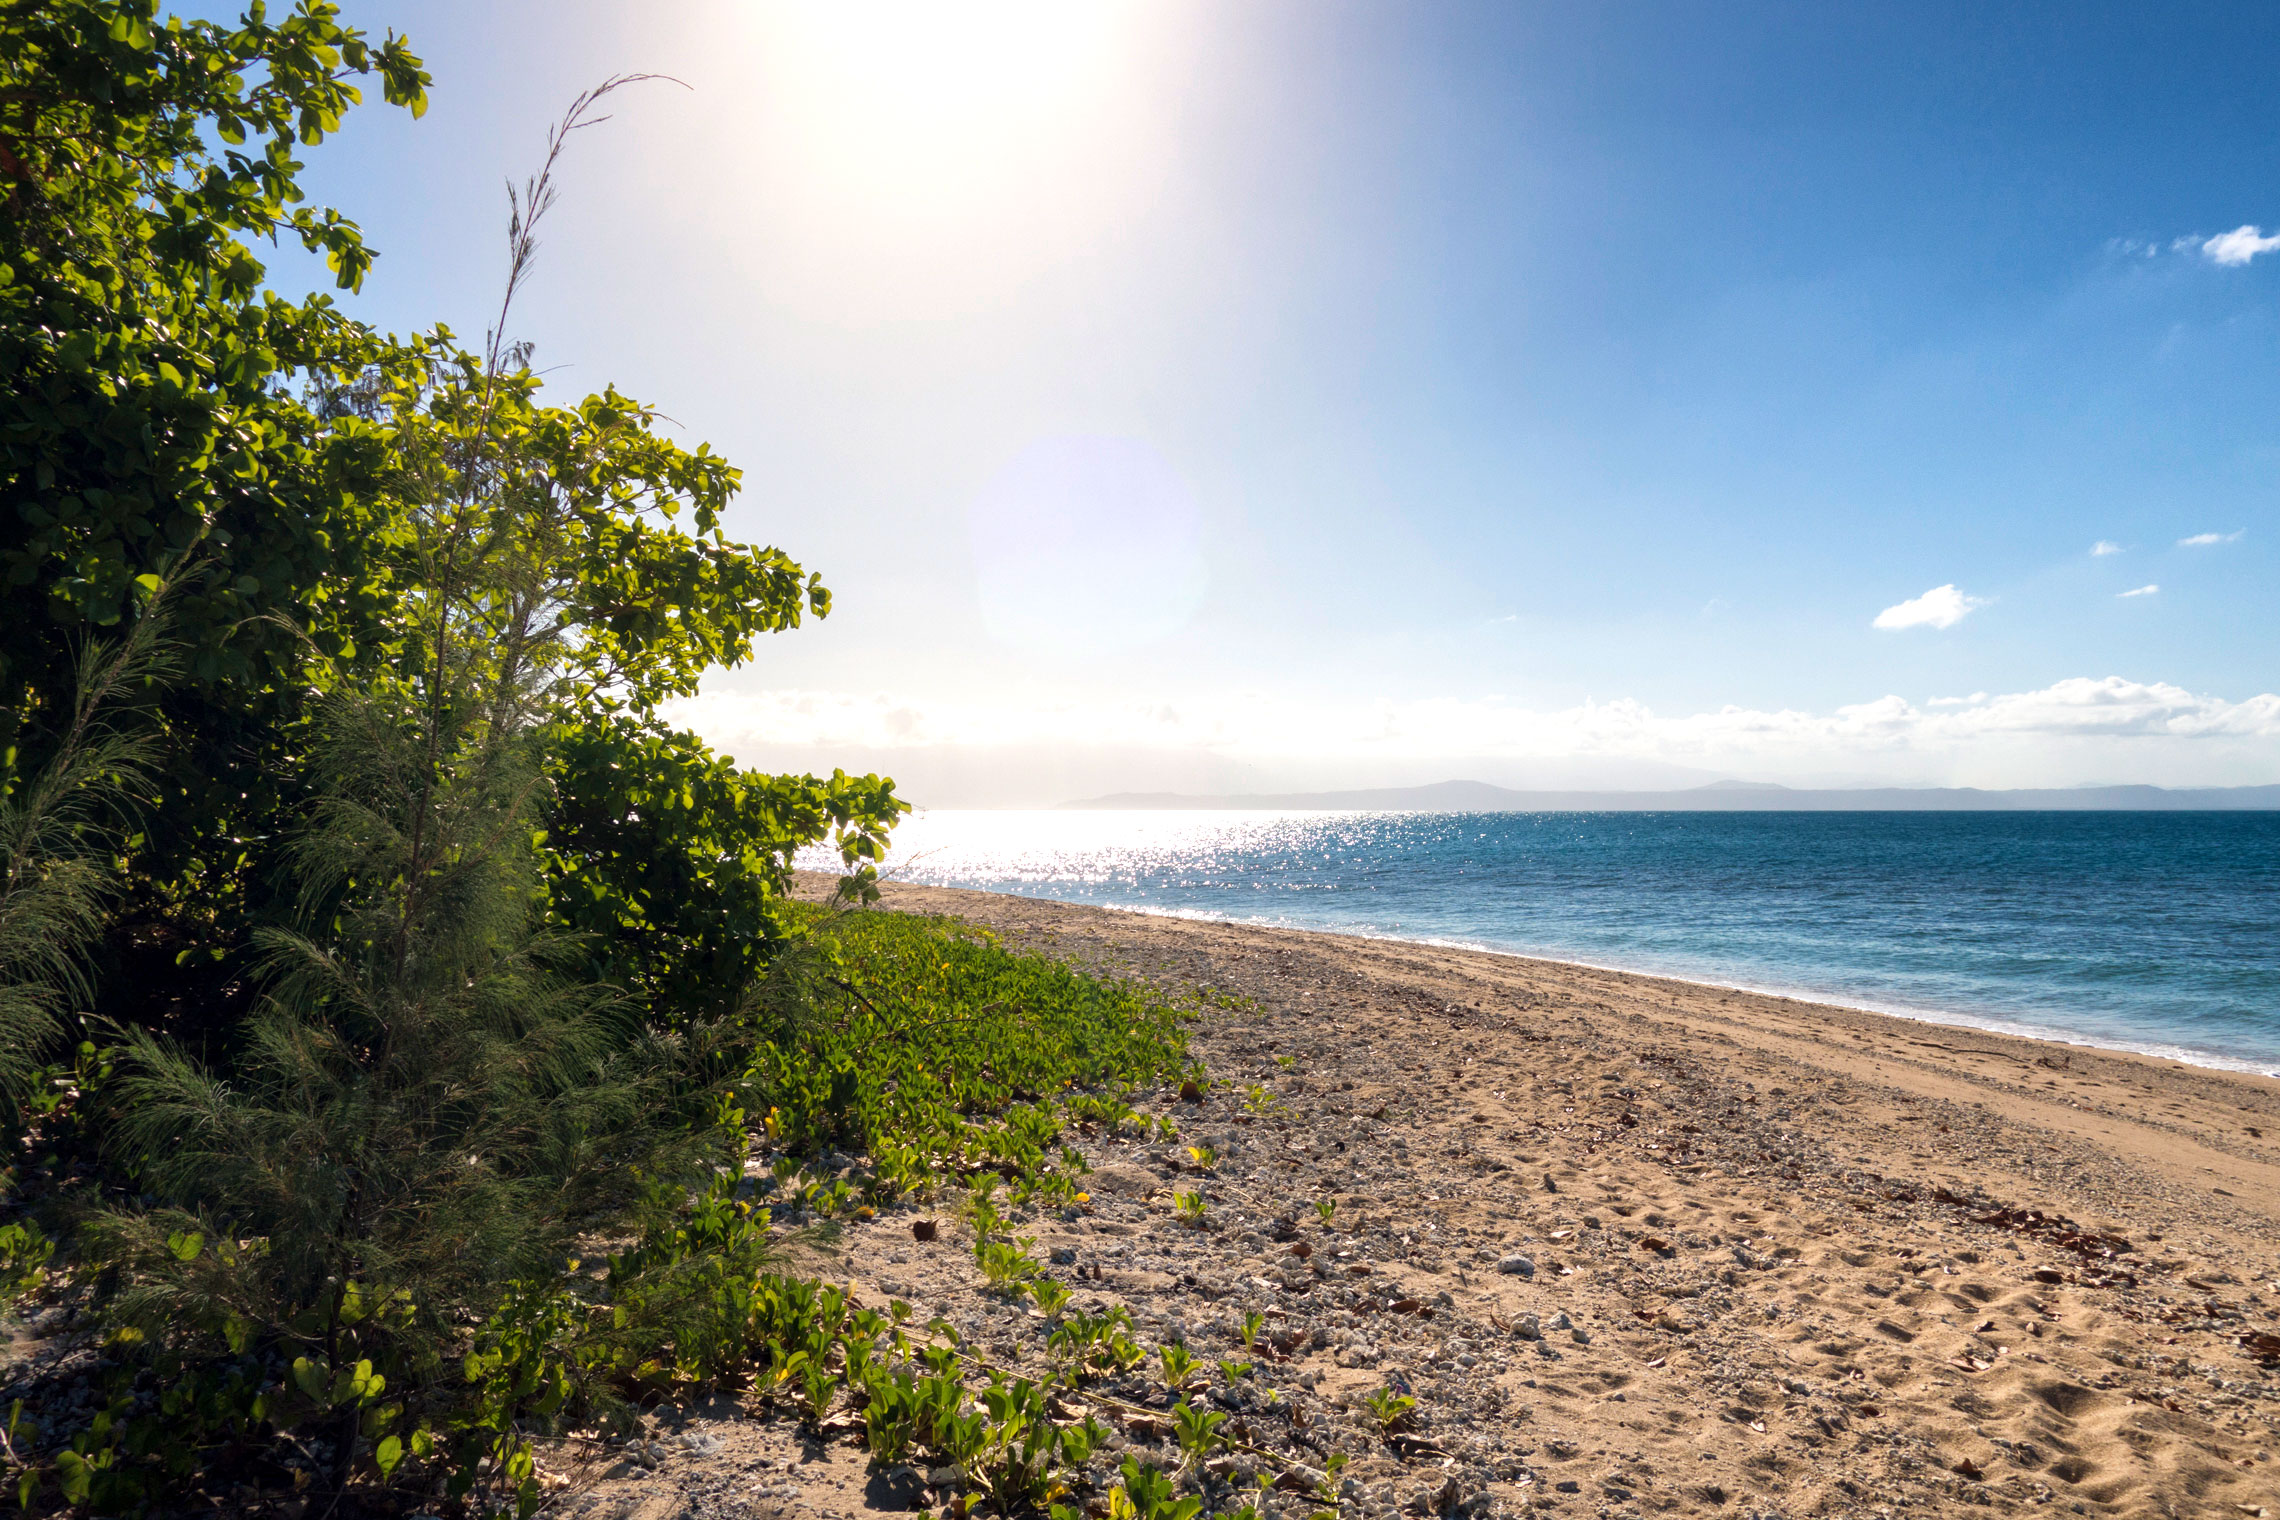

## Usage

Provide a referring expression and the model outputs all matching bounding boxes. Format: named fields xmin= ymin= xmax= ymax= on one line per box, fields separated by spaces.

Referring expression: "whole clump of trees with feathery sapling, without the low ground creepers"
xmin=0 ymin=0 xmax=905 ymax=1513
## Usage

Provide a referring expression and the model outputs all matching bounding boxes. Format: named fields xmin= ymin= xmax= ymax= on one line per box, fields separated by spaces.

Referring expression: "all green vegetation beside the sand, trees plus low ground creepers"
xmin=0 ymin=0 xmax=1247 ymax=1520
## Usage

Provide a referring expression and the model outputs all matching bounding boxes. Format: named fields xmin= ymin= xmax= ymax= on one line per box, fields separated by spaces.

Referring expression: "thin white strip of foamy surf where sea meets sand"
xmin=875 ymin=882 xmax=2280 ymax=1078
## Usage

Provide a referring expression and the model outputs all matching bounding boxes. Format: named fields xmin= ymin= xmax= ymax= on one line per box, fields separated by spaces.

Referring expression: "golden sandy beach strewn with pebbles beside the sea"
xmin=570 ymin=886 xmax=2280 ymax=1520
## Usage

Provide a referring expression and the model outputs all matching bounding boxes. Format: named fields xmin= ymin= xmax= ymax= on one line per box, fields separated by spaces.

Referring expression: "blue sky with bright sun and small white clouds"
xmin=274 ymin=2 xmax=2280 ymax=804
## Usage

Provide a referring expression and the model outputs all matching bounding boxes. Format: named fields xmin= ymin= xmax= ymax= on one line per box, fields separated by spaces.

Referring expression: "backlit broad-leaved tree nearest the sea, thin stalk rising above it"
xmin=332 ymin=75 xmax=907 ymax=1019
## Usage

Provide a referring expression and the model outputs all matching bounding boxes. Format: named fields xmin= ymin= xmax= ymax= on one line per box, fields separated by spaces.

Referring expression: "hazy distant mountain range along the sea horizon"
xmin=1062 ymin=782 xmax=2280 ymax=814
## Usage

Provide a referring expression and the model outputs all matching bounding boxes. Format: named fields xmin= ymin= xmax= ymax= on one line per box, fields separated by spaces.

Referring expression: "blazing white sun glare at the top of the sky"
xmin=670 ymin=0 xmax=1192 ymax=328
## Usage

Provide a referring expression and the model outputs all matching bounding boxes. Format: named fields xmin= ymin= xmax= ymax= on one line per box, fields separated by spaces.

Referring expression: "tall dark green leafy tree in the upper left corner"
xmin=0 ymin=0 xmax=429 ymax=715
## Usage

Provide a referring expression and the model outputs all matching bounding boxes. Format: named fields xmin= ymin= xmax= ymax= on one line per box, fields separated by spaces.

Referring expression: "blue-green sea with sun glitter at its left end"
xmin=803 ymin=809 xmax=2280 ymax=1076
